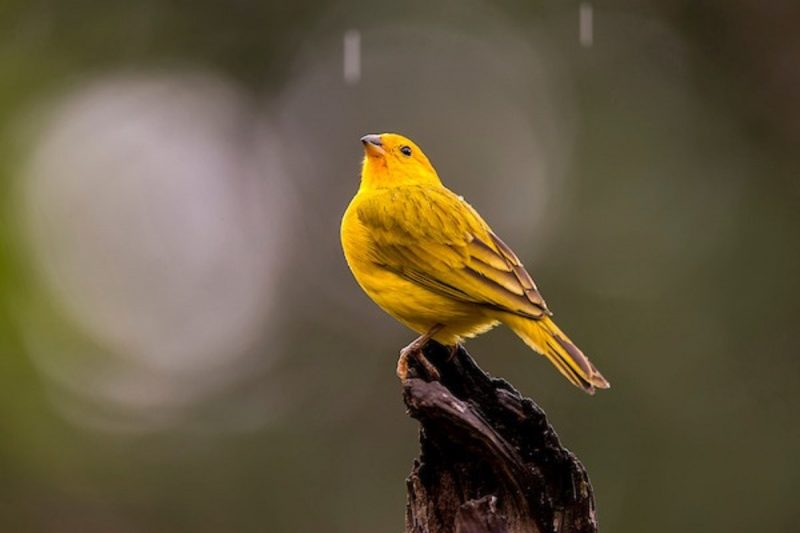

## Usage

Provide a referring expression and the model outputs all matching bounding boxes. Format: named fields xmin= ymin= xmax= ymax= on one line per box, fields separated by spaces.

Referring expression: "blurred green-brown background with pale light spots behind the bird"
xmin=0 ymin=0 xmax=800 ymax=533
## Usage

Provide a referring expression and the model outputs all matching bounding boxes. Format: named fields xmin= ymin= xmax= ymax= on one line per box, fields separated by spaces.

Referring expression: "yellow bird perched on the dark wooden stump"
xmin=341 ymin=133 xmax=609 ymax=394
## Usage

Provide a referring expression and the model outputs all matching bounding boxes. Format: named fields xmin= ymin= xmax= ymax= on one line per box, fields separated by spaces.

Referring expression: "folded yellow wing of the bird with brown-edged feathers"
xmin=358 ymin=187 xmax=550 ymax=318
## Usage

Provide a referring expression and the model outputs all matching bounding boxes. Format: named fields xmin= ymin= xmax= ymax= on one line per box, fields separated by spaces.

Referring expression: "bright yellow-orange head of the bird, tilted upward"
xmin=361 ymin=133 xmax=441 ymax=188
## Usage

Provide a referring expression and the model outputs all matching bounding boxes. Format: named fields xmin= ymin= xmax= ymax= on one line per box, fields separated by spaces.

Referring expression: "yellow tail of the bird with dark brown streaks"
xmin=500 ymin=313 xmax=611 ymax=394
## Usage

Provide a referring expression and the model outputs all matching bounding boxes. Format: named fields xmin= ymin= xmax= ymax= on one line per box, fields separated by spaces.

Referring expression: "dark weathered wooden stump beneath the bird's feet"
xmin=404 ymin=342 xmax=597 ymax=533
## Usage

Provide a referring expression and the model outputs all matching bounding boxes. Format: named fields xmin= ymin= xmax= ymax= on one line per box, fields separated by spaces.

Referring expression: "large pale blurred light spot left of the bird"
xmin=21 ymin=70 xmax=286 ymax=428
